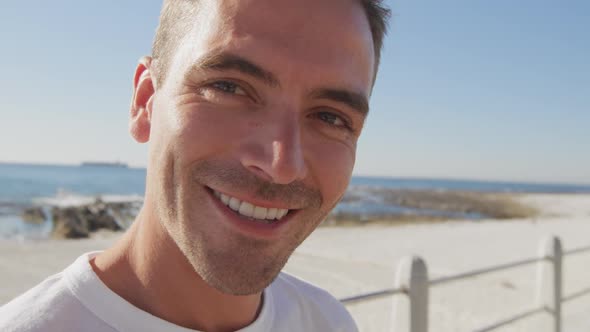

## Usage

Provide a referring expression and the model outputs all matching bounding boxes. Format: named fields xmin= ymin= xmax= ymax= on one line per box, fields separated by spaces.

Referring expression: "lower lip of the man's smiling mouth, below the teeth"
xmin=207 ymin=188 xmax=297 ymax=239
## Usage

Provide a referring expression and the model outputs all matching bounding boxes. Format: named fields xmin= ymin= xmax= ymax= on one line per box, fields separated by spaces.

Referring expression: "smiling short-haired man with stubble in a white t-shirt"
xmin=0 ymin=0 xmax=388 ymax=331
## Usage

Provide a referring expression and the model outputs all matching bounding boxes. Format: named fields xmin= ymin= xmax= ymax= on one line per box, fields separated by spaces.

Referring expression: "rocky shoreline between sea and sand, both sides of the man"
xmin=0 ymin=191 xmax=590 ymax=240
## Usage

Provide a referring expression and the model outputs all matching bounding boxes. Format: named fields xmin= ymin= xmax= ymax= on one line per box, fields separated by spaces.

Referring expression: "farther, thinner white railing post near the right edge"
xmin=537 ymin=236 xmax=563 ymax=332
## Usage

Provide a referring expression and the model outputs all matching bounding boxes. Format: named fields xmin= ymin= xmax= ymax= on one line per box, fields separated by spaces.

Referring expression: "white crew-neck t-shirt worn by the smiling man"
xmin=0 ymin=252 xmax=357 ymax=332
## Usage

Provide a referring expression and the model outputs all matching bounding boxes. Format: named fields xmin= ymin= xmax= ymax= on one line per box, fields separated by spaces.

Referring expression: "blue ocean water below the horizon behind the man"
xmin=0 ymin=164 xmax=590 ymax=239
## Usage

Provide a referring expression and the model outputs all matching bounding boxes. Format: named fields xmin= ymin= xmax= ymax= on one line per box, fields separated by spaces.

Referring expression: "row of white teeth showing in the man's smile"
xmin=213 ymin=190 xmax=289 ymax=224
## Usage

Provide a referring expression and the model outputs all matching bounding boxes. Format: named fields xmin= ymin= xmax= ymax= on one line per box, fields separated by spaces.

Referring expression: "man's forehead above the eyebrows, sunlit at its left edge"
xmin=171 ymin=0 xmax=374 ymax=94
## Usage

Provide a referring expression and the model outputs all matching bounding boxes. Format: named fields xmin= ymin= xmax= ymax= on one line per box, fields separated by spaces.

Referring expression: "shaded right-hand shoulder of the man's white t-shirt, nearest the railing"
xmin=271 ymin=272 xmax=357 ymax=331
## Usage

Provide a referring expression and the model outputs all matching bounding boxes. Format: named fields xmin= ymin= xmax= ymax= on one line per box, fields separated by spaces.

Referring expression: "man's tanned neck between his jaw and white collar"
xmin=91 ymin=206 xmax=262 ymax=332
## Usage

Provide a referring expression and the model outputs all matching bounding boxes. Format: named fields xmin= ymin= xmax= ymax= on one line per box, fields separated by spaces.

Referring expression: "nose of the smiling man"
xmin=241 ymin=112 xmax=308 ymax=184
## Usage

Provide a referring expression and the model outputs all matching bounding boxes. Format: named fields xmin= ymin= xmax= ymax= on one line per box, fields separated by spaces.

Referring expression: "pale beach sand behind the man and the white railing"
xmin=0 ymin=194 xmax=590 ymax=332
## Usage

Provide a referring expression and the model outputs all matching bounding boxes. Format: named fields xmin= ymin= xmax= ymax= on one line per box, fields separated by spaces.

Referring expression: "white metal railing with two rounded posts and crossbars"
xmin=340 ymin=236 xmax=590 ymax=332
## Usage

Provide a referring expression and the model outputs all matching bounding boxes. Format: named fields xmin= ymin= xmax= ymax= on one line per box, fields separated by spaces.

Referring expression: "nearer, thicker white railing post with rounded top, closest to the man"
xmin=391 ymin=256 xmax=428 ymax=332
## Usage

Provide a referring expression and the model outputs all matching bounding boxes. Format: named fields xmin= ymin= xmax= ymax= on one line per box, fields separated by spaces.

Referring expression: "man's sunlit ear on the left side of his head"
xmin=129 ymin=56 xmax=156 ymax=143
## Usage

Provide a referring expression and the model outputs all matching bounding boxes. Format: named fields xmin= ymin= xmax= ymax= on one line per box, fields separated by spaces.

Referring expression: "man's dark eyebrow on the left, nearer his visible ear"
xmin=189 ymin=52 xmax=280 ymax=87
